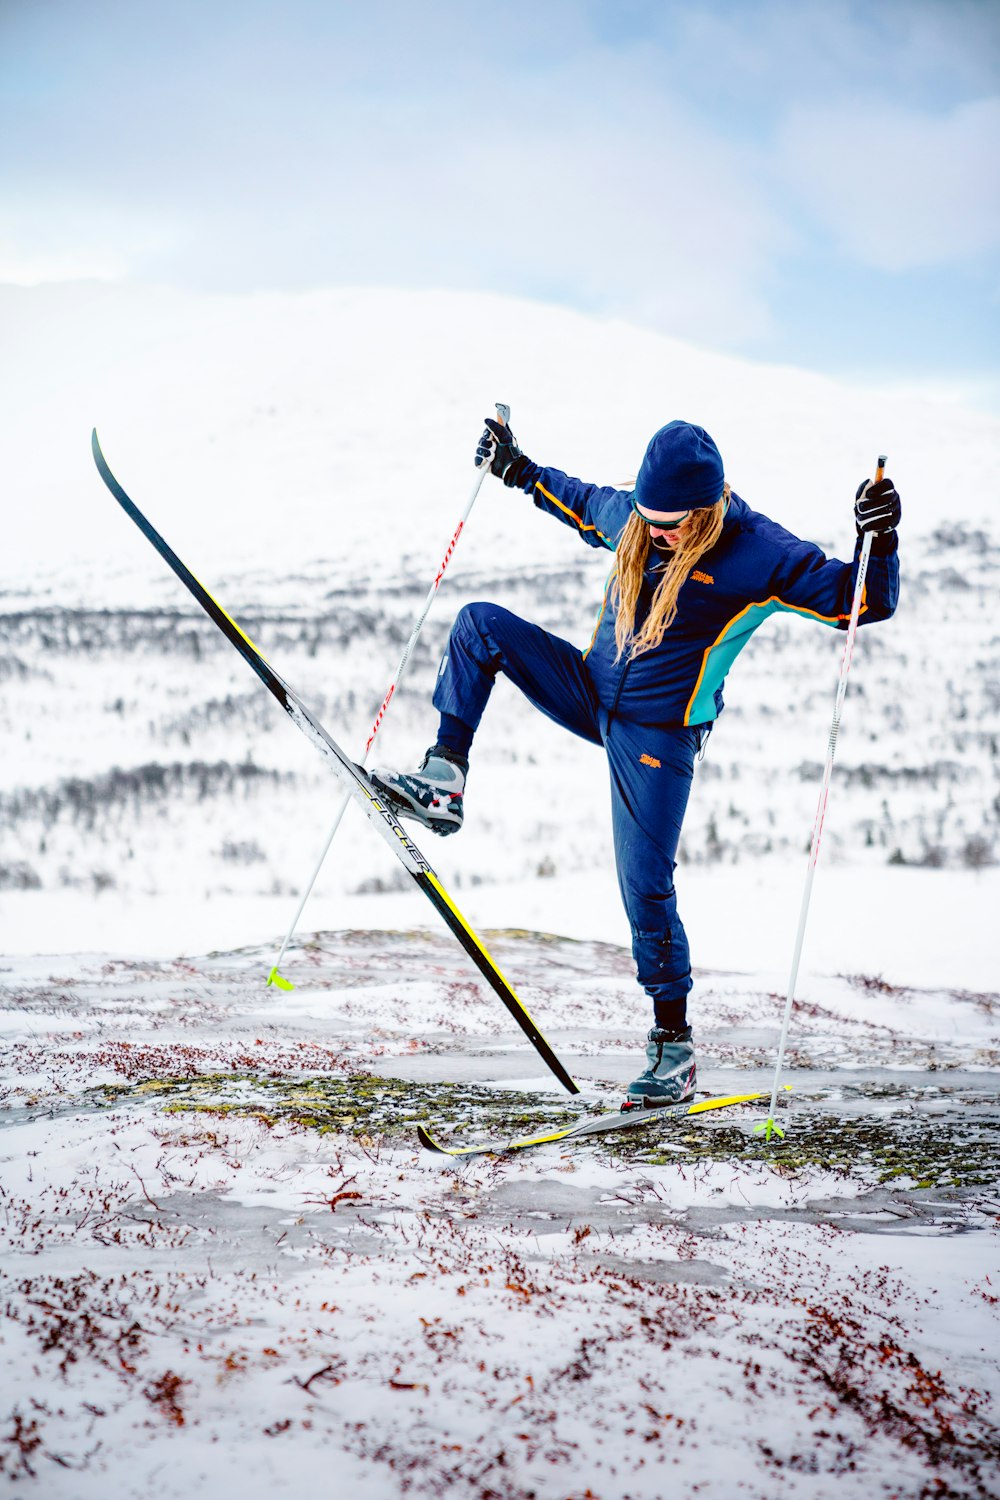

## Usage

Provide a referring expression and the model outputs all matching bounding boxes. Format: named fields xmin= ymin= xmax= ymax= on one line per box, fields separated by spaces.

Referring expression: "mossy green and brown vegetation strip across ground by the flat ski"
xmin=76 ymin=1073 xmax=999 ymax=1188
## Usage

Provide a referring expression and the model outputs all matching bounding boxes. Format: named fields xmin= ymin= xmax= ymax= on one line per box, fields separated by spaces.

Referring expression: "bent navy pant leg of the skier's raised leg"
xmin=433 ymin=605 xmax=601 ymax=744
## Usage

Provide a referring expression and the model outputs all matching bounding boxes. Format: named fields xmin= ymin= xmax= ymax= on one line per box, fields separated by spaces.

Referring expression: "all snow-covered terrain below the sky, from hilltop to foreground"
xmin=0 ymin=288 xmax=1000 ymax=1500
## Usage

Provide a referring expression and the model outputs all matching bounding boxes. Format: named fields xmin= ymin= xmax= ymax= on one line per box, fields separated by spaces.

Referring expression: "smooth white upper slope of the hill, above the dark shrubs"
xmin=0 ymin=284 xmax=1000 ymax=588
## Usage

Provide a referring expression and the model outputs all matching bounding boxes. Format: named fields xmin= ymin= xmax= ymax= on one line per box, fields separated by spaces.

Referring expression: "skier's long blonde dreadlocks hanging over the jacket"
xmin=612 ymin=485 xmax=732 ymax=662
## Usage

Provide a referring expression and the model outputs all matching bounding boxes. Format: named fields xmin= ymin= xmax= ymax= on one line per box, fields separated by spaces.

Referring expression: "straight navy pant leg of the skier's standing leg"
xmin=606 ymin=717 xmax=702 ymax=1025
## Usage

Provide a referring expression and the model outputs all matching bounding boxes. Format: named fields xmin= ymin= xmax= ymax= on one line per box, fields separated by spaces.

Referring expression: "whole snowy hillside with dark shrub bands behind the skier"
xmin=0 ymin=287 xmax=1000 ymax=962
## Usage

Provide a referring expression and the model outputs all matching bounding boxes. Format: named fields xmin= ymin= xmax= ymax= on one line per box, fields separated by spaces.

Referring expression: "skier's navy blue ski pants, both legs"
xmin=433 ymin=605 xmax=711 ymax=1025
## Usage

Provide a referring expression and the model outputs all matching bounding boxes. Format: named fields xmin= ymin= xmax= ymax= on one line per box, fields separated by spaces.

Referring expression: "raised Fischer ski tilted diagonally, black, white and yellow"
xmin=90 ymin=428 xmax=580 ymax=1094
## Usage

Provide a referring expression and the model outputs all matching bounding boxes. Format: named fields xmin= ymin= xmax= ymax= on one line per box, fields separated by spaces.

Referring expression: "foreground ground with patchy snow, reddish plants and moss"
xmin=0 ymin=930 xmax=1000 ymax=1500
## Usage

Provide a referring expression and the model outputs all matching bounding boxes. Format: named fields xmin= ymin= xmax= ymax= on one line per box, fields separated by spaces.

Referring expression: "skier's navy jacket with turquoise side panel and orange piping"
xmin=522 ymin=465 xmax=900 ymax=725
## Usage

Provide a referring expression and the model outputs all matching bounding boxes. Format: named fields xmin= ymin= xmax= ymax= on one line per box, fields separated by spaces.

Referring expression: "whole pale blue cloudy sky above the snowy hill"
xmin=0 ymin=0 xmax=1000 ymax=393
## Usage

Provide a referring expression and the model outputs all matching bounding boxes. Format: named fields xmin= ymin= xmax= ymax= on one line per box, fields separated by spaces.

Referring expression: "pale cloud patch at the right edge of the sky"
xmin=778 ymin=99 xmax=1000 ymax=272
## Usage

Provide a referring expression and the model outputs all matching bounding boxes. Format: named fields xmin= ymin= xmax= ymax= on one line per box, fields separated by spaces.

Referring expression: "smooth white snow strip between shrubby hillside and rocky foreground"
xmin=1 ymin=858 xmax=1000 ymax=990
